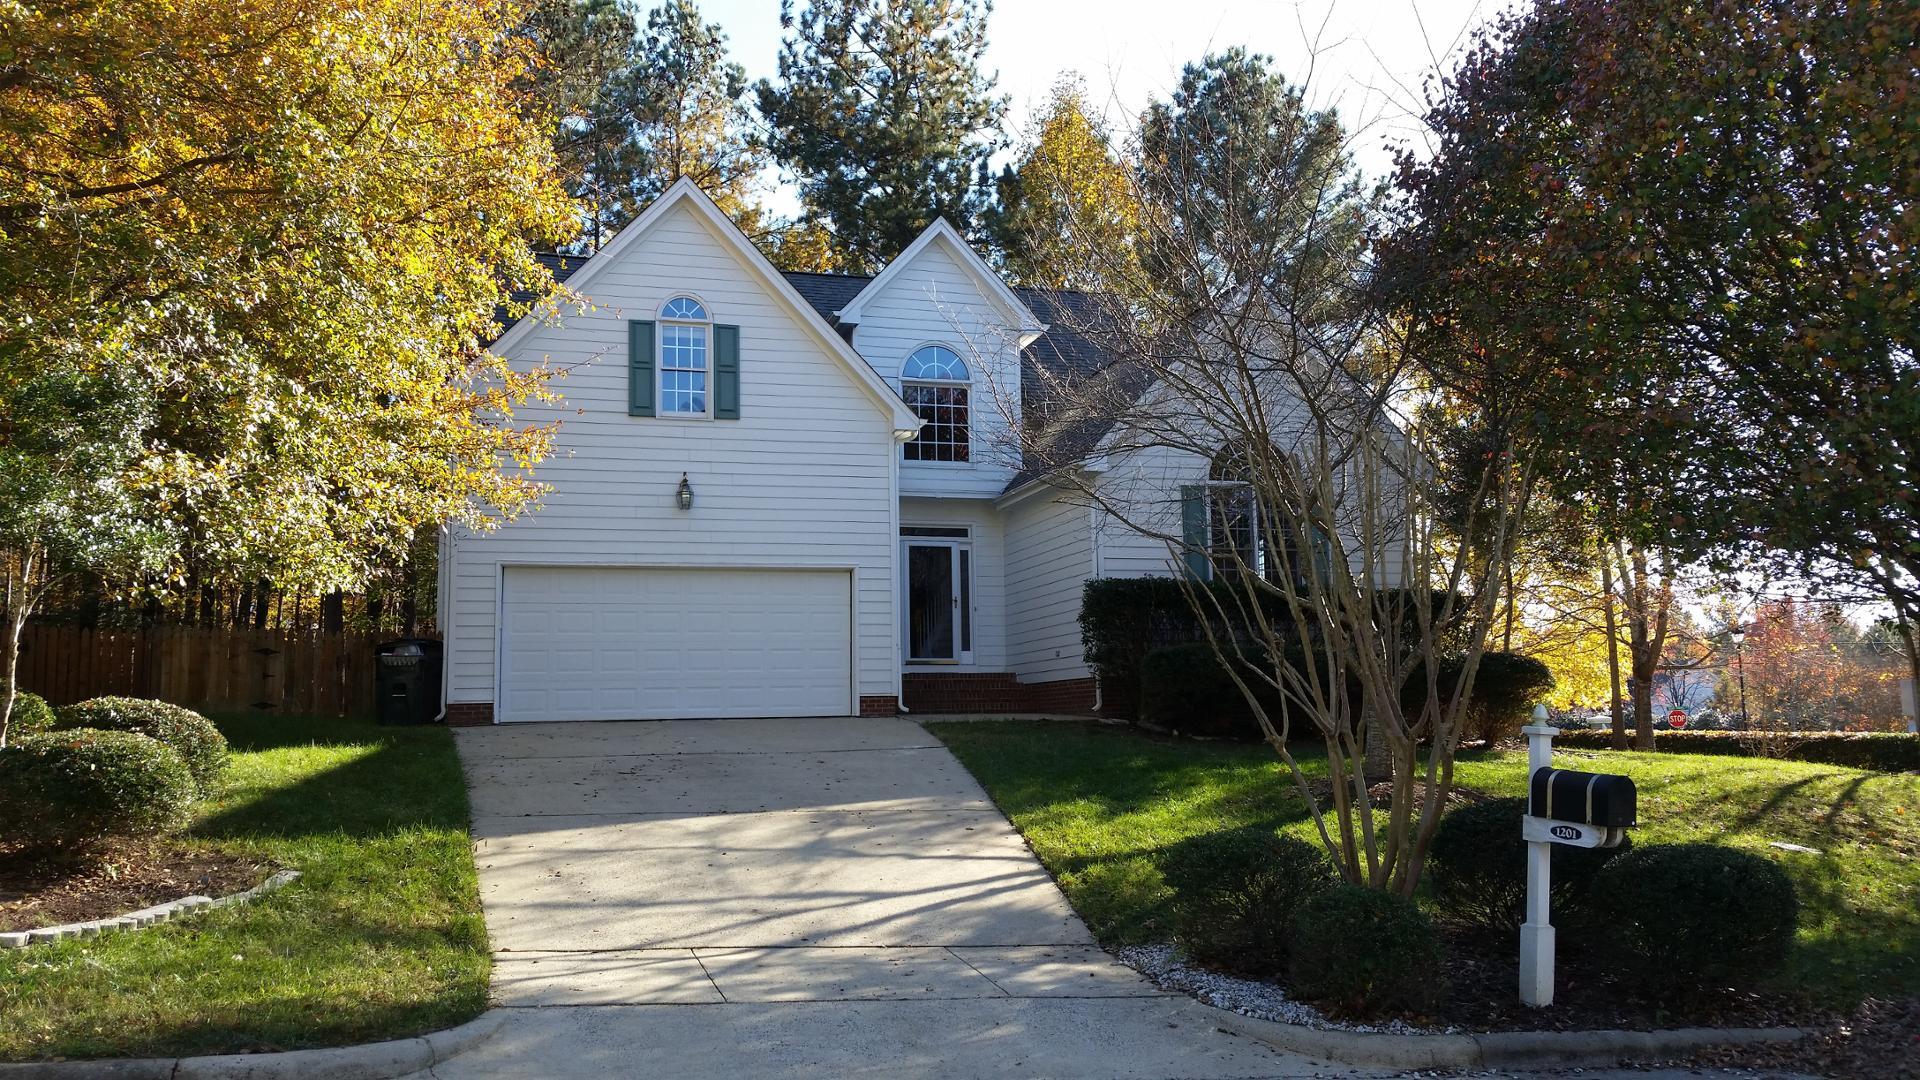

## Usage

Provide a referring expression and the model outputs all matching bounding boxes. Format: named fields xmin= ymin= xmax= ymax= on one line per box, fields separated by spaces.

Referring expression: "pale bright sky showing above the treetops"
xmin=701 ymin=0 xmax=1505 ymax=200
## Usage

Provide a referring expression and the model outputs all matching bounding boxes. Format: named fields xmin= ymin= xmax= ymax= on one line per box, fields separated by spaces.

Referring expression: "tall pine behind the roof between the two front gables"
xmin=758 ymin=0 xmax=1006 ymax=271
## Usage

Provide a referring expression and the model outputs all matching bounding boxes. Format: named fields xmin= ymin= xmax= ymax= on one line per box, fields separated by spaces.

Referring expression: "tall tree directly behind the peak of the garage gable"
xmin=534 ymin=0 xmax=766 ymax=250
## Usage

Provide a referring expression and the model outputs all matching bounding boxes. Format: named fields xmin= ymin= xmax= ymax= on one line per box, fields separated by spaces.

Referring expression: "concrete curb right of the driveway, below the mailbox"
xmin=1210 ymin=1007 xmax=1809 ymax=1068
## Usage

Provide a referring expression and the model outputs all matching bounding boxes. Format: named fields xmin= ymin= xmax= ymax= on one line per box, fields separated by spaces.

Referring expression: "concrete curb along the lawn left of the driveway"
xmin=0 ymin=1009 xmax=507 ymax=1080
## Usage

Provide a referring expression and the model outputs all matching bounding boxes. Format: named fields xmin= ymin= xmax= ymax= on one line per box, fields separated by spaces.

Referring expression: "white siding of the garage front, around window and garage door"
xmin=447 ymin=206 xmax=899 ymax=701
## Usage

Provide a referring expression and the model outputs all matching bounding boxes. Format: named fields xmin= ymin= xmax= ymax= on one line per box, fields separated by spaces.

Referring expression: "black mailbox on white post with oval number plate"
xmin=1521 ymin=705 xmax=1636 ymax=1009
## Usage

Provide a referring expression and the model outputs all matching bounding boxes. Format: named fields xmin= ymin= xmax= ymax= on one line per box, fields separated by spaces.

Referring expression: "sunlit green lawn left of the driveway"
xmin=0 ymin=717 xmax=490 ymax=1061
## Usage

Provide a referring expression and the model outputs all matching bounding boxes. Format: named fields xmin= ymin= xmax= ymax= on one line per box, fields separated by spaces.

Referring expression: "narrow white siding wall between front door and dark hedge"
xmin=1006 ymin=496 xmax=1092 ymax=682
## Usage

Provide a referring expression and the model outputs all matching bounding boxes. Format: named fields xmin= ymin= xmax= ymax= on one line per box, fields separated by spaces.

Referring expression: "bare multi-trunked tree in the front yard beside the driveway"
xmin=998 ymin=52 xmax=1532 ymax=896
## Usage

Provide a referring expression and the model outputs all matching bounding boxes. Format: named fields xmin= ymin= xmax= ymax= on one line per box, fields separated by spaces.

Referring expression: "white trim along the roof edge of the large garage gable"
xmin=488 ymin=177 xmax=922 ymax=428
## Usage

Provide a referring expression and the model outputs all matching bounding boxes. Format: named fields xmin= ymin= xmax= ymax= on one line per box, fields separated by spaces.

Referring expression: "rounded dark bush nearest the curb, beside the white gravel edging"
xmin=1290 ymin=884 xmax=1446 ymax=1017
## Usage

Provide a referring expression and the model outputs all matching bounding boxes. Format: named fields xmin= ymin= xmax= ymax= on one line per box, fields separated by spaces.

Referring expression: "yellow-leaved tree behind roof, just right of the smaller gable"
xmin=987 ymin=75 xmax=1139 ymax=288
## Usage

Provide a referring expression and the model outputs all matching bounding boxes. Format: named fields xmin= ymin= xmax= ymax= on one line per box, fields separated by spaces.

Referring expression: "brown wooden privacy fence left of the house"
xmin=19 ymin=625 xmax=378 ymax=715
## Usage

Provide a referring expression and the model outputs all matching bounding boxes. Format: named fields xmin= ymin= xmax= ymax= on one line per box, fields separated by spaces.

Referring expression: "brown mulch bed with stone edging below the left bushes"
xmin=0 ymin=840 xmax=265 ymax=932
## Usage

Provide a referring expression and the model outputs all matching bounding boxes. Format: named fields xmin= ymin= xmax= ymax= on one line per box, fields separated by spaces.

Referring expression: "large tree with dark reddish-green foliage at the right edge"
xmin=1388 ymin=0 xmax=1920 ymax=707
